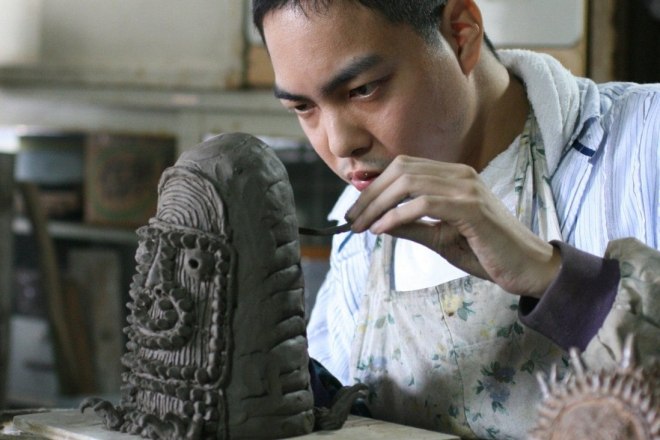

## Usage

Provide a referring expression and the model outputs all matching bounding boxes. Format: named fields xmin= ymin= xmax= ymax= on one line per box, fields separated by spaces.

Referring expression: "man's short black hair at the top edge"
xmin=252 ymin=0 xmax=497 ymax=57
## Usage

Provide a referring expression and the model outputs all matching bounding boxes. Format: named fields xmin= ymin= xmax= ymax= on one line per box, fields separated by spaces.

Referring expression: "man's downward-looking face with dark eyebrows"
xmin=264 ymin=0 xmax=475 ymax=190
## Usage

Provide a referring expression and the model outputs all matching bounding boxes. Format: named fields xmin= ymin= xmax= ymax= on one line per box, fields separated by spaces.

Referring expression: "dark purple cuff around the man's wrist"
xmin=518 ymin=241 xmax=620 ymax=350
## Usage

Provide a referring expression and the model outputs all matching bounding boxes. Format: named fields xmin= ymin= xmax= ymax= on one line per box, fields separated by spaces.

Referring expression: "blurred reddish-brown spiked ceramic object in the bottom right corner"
xmin=530 ymin=337 xmax=660 ymax=440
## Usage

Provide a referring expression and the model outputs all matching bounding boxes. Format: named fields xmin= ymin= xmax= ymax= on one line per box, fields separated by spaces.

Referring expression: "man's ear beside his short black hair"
xmin=440 ymin=0 xmax=484 ymax=75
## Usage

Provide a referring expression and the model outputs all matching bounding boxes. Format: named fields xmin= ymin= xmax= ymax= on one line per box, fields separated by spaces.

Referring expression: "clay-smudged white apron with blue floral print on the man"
xmin=350 ymin=115 xmax=566 ymax=439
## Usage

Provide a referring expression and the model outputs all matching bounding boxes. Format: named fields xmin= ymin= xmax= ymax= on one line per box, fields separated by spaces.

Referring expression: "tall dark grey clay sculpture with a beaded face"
xmin=81 ymin=133 xmax=364 ymax=440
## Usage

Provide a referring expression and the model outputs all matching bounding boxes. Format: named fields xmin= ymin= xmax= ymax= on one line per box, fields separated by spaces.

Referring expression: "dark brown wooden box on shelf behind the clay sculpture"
xmin=84 ymin=133 xmax=176 ymax=228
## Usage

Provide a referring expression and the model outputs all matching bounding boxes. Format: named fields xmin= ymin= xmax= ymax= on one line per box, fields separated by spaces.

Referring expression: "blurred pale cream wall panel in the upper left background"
xmin=0 ymin=0 xmax=245 ymax=90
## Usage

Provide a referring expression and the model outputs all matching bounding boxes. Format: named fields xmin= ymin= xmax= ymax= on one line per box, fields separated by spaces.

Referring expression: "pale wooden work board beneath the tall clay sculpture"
xmin=5 ymin=410 xmax=459 ymax=440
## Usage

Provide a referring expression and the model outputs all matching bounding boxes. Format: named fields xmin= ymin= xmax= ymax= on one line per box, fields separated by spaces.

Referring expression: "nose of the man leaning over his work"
xmin=324 ymin=112 xmax=369 ymax=157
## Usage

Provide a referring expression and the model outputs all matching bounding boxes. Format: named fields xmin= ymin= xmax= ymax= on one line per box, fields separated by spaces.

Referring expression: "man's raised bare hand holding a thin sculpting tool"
xmin=346 ymin=156 xmax=561 ymax=298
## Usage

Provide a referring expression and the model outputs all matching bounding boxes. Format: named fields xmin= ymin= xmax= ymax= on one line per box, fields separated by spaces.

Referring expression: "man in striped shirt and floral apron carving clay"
xmin=253 ymin=0 xmax=660 ymax=438
